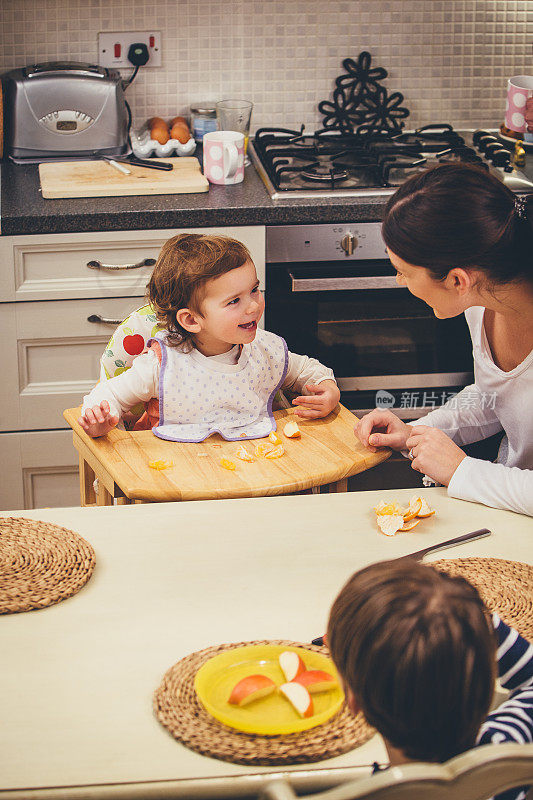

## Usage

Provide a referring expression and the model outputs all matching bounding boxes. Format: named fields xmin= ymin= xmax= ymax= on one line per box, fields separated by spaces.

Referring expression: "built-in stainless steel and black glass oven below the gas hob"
xmin=265 ymin=222 xmax=472 ymax=419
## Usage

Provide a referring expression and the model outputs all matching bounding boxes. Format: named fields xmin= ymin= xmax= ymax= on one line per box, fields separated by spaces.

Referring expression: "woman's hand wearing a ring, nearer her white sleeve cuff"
xmin=405 ymin=425 xmax=466 ymax=486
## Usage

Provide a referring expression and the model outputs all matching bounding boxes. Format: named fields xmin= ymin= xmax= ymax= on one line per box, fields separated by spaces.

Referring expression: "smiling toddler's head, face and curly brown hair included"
xmin=148 ymin=233 xmax=263 ymax=349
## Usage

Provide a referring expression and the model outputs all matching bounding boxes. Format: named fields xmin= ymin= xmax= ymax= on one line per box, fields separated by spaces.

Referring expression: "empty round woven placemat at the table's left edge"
xmin=0 ymin=517 xmax=95 ymax=614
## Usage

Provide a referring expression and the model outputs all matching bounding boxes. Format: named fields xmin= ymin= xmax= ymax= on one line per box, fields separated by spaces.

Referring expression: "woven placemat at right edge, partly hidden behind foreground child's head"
xmin=429 ymin=558 xmax=533 ymax=639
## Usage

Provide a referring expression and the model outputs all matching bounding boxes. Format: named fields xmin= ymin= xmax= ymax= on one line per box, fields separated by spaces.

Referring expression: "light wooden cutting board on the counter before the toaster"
xmin=39 ymin=156 xmax=209 ymax=198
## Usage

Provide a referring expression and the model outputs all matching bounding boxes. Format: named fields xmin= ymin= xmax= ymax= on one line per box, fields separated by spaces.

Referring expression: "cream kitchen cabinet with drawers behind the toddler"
xmin=0 ymin=226 xmax=265 ymax=509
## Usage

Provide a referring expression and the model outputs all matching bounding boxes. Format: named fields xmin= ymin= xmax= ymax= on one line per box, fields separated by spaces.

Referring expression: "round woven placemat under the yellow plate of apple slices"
xmin=154 ymin=639 xmax=375 ymax=766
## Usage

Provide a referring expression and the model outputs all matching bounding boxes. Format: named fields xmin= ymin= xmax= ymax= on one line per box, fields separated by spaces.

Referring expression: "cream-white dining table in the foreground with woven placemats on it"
xmin=0 ymin=489 xmax=533 ymax=800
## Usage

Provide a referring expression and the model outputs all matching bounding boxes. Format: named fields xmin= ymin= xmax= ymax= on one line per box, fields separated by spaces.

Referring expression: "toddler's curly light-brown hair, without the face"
xmin=148 ymin=233 xmax=252 ymax=347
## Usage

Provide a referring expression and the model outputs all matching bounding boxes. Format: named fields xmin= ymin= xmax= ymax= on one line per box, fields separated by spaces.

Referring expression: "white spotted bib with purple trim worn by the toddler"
xmin=150 ymin=330 xmax=288 ymax=442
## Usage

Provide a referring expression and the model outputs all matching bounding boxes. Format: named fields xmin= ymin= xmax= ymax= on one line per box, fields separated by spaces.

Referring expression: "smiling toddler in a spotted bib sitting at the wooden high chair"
xmin=79 ymin=234 xmax=340 ymax=442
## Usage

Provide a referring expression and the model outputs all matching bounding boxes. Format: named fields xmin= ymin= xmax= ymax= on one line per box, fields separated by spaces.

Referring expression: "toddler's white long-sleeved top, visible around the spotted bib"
xmin=82 ymin=345 xmax=335 ymax=417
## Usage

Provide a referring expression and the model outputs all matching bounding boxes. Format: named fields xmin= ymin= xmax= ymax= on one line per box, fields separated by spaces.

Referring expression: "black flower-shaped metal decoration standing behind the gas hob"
xmin=318 ymin=51 xmax=409 ymax=134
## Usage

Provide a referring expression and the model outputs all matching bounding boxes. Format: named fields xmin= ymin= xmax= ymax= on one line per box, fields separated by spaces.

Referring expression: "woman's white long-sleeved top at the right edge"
xmin=413 ymin=306 xmax=533 ymax=516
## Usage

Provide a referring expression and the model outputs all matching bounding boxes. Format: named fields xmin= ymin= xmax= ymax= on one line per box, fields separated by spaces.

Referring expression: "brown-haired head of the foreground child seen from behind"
xmin=327 ymin=560 xmax=496 ymax=762
